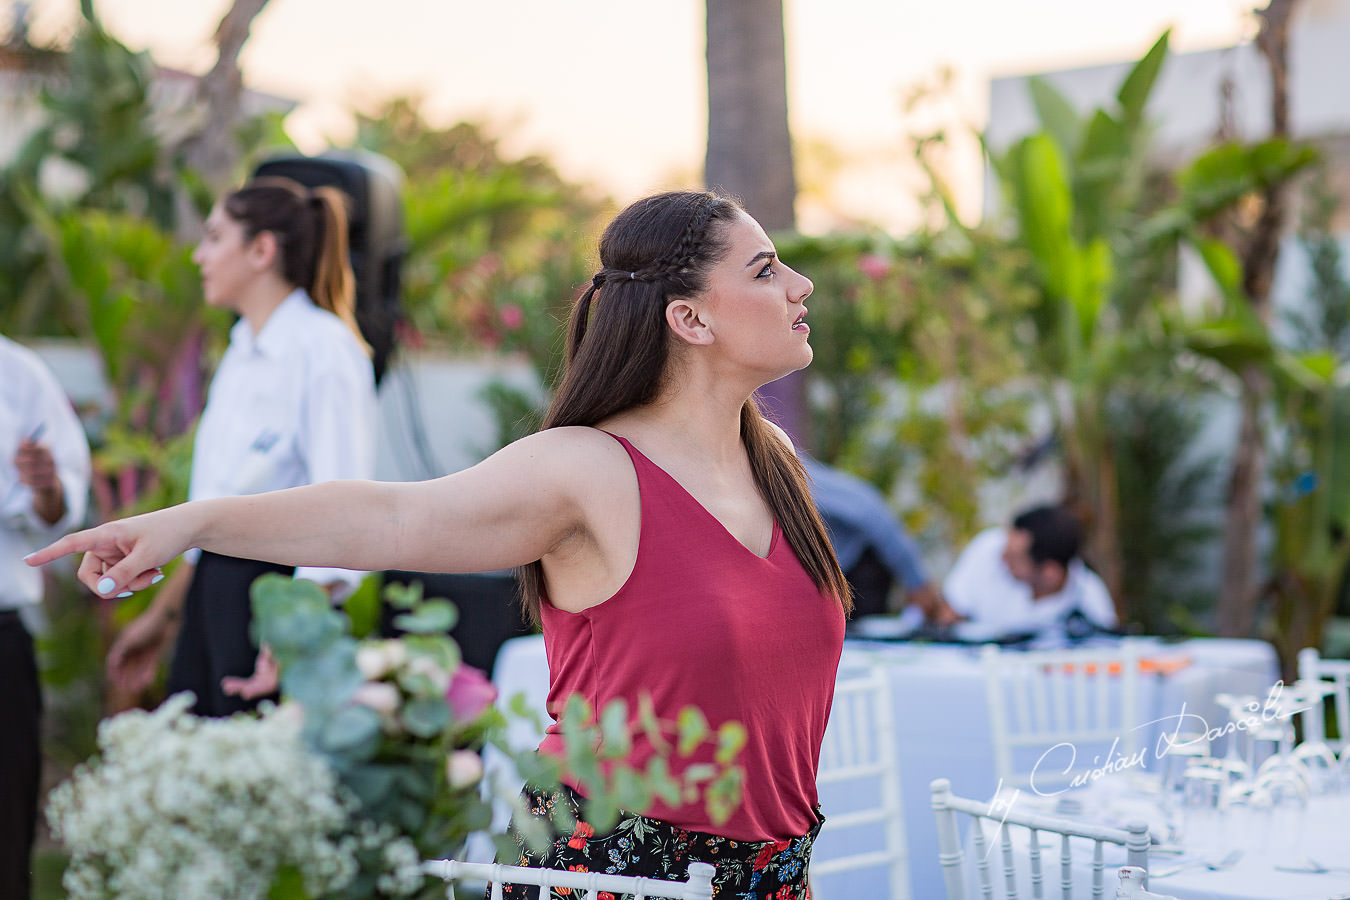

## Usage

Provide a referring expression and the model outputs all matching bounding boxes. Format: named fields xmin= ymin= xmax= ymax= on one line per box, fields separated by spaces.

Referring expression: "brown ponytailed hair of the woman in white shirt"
xmin=223 ymin=177 xmax=370 ymax=354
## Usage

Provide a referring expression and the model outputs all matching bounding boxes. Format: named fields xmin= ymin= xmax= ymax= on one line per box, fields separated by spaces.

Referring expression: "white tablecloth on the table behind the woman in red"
xmin=493 ymin=637 xmax=1278 ymax=900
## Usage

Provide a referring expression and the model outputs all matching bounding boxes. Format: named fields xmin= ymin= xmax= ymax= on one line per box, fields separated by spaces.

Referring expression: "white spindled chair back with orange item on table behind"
xmin=981 ymin=641 xmax=1141 ymax=788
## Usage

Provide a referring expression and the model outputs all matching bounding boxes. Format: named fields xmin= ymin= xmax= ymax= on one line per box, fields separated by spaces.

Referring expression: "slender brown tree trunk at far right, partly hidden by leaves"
xmin=1218 ymin=0 xmax=1299 ymax=637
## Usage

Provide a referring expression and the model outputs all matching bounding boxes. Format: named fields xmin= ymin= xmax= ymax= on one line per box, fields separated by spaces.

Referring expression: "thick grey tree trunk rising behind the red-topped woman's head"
xmin=703 ymin=0 xmax=813 ymax=447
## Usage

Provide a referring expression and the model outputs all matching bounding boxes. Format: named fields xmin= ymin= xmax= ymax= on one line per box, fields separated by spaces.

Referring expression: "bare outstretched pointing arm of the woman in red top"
xmin=27 ymin=429 xmax=596 ymax=596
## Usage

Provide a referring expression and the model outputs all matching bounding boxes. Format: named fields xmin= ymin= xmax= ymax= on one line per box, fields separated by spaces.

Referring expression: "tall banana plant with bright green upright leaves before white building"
xmin=992 ymin=34 xmax=1227 ymax=620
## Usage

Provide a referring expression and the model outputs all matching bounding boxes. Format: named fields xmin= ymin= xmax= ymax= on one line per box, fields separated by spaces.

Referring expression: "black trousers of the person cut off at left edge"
xmin=0 ymin=611 xmax=42 ymax=900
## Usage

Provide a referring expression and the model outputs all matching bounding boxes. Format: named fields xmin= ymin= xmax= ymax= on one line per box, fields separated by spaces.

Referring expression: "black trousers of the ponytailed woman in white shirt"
xmin=169 ymin=553 xmax=296 ymax=716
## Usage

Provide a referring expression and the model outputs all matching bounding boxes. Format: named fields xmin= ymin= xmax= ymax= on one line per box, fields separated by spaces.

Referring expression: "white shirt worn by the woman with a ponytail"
xmin=188 ymin=289 xmax=375 ymax=587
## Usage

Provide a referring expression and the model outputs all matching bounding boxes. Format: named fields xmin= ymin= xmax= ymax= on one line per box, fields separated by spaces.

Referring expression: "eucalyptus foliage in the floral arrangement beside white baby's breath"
xmin=252 ymin=575 xmax=744 ymax=896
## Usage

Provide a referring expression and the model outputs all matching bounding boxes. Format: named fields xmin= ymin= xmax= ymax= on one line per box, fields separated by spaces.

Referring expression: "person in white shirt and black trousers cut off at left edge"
xmin=0 ymin=335 xmax=89 ymax=900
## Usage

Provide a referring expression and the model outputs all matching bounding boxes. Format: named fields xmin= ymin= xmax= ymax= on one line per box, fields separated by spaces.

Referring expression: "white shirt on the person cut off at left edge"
xmin=0 ymin=336 xmax=89 ymax=610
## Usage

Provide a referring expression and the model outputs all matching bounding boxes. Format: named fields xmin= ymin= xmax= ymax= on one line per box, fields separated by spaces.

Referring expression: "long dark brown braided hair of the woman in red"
xmin=520 ymin=192 xmax=853 ymax=625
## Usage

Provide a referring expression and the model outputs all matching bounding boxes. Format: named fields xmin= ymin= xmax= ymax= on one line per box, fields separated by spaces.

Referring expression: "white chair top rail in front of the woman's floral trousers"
xmin=423 ymin=860 xmax=717 ymax=900
